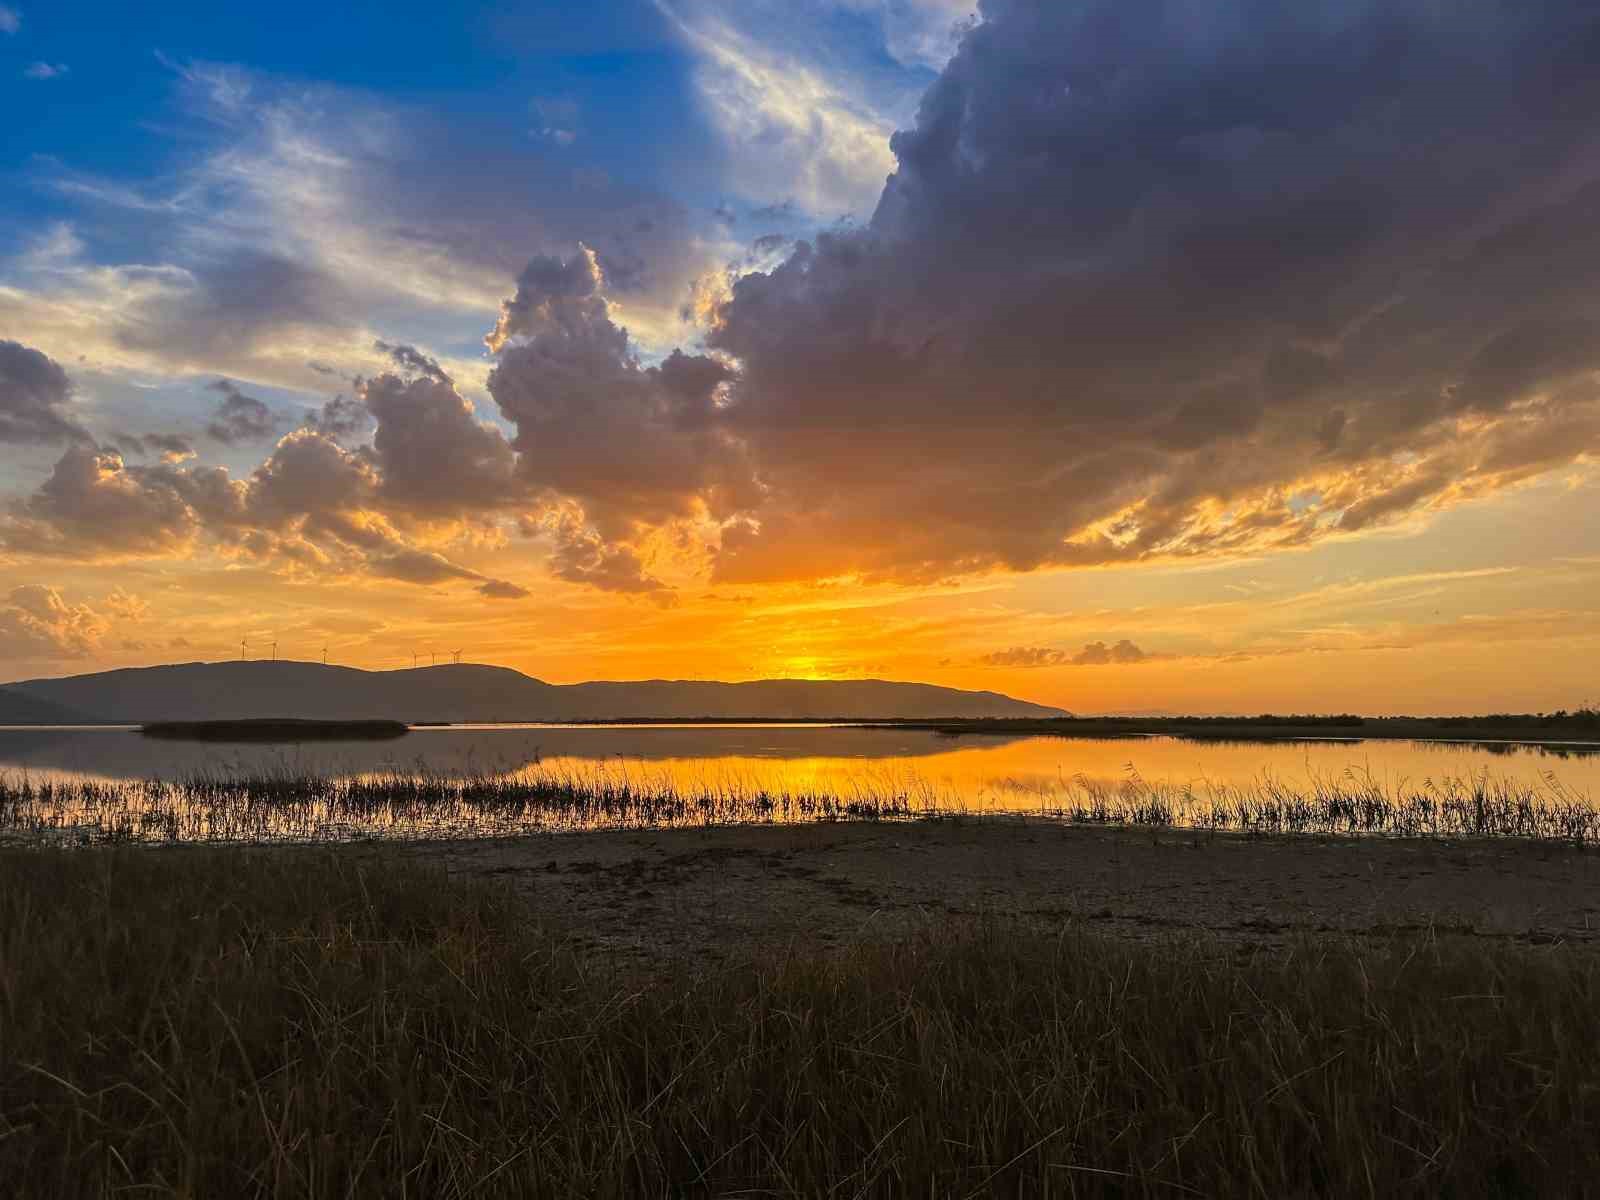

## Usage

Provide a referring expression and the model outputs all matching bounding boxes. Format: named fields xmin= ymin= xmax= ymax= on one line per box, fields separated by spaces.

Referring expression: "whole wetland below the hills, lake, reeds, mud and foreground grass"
xmin=0 ymin=726 xmax=1600 ymax=1197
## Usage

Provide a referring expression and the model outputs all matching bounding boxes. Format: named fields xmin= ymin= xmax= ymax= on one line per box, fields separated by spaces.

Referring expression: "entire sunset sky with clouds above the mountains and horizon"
xmin=0 ymin=0 xmax=1600 ymax=714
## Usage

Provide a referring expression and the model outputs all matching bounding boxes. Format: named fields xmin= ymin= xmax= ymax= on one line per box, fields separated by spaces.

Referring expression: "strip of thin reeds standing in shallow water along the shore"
xmin=0 ymin=765 xmax=1600 ymax=846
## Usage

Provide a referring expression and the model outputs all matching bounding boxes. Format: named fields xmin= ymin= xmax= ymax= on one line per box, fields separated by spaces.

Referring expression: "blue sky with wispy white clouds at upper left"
xmin=0 ymin=0 xmax=960 ymax=475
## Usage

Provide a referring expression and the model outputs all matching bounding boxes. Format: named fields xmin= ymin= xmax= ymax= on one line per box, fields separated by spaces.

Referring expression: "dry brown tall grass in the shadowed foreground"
xmin=0 ymin=848 xmax=1600 ymax=1197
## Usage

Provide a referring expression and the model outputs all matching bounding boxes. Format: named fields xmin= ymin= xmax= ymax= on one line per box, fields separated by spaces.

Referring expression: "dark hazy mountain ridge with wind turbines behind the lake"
xmin=5 ymin=661 xmax=1066 ymax=722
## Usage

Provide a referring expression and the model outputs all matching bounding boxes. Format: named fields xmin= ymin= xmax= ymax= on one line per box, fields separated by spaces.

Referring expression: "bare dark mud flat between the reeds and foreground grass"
xmin=400 ymin=818 xmax=1600 ymax=966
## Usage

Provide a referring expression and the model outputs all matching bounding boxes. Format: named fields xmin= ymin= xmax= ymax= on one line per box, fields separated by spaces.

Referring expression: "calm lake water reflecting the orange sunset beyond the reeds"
xmin=0 ymin=725 xmax=1600 ymax=837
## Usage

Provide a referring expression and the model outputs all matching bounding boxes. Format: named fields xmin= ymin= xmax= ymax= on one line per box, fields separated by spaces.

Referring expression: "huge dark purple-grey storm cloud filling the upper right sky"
xmin=490 ymin=0 xmax=1600 ymax=579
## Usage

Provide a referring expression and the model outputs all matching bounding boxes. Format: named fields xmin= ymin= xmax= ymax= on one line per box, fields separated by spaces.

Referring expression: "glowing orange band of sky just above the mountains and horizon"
xmin=0 ymin=474 xmax=1600 ymax=714
